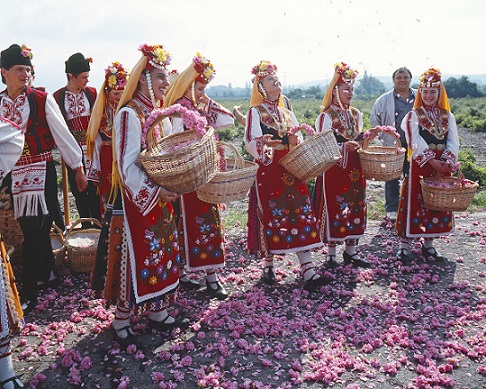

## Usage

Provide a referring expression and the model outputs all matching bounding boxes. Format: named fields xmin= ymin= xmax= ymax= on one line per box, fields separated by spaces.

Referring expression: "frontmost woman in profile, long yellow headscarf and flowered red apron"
xmin=93 ymin=44 xmax=189 ymax=346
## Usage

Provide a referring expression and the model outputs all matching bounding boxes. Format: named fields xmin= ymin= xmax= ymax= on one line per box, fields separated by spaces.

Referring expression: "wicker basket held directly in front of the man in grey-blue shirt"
xmin=358 ymin=130 xmax=405 ymax=181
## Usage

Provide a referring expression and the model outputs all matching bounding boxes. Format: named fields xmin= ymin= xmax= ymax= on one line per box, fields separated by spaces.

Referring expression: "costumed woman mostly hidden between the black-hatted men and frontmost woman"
xmin=87 ymin=62 xmax=129 ymax=215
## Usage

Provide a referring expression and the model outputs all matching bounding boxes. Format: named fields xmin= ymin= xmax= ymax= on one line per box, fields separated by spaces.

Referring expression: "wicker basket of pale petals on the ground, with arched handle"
xmin=65 ymin=218 xmax=101 ymax=273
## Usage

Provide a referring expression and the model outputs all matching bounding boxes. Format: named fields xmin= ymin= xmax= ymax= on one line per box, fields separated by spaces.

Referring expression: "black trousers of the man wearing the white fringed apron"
xmin=19 ymin=162 xmax=59 ymax=301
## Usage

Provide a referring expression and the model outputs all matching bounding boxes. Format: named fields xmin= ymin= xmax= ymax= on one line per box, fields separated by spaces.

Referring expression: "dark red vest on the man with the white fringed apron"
xmin=22 ymin=88 xmax=56 ymax=156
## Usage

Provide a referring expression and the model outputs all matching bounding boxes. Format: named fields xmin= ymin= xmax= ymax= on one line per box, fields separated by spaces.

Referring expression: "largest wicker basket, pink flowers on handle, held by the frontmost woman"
xmin=139 ymin=104 xmax=217 ymax=194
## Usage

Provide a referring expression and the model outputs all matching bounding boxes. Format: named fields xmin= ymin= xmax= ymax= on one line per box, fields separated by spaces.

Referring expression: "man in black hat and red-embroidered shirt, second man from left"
xmin=54 ymin=53 xmax=101 ymax=227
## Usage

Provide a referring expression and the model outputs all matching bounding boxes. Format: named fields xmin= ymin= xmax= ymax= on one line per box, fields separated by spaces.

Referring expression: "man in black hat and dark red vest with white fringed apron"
xmin=0 ymin=44 xmax=86 ymax=312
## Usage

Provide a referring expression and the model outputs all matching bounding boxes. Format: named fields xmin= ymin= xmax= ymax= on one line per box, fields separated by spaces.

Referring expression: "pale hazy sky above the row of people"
xmin=0 ymin=0 xmax=486 ymax=92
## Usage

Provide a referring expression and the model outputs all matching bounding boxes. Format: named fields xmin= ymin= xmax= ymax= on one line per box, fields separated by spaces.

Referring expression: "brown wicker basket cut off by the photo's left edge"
xmin=0 ymin=188 xmax=24 ymax=259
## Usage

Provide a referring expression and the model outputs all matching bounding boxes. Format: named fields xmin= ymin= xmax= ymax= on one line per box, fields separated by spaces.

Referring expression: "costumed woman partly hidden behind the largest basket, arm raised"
xmin=164 ymin=53 xmax=234 ymax=300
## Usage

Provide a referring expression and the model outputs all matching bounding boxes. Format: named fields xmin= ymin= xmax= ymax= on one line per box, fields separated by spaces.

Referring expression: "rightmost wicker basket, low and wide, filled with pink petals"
xmin=420 ymin=171 xmax=479 ymax=212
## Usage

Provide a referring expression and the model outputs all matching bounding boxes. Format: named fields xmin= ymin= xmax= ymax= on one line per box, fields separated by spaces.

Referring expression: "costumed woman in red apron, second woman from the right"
xmin=314 ymin=62 xmax=370 ymax=267
